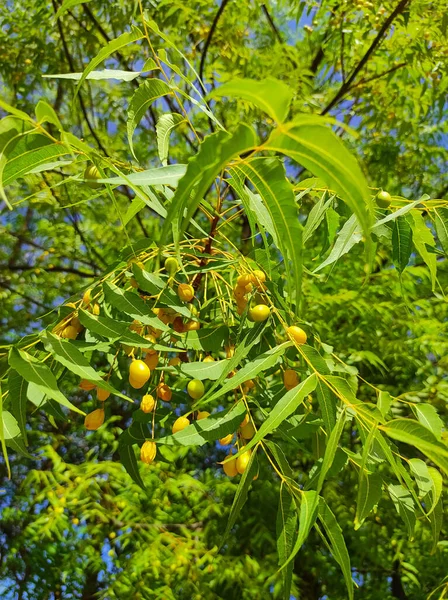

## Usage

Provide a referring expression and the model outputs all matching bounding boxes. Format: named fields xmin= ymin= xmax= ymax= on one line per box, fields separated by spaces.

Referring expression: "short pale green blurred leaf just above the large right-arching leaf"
xmin=209 ymin=77 xmax=294 ymax=123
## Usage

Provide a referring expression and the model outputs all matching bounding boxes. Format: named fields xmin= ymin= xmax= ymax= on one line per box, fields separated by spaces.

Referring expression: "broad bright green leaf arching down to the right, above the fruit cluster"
xmin=263 ymin=115 xmax=373 ymax=235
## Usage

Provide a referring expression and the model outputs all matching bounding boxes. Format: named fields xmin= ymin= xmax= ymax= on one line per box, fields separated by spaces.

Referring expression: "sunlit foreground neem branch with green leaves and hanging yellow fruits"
xmin=0 ymin=8 xmax=448 ymax=598
